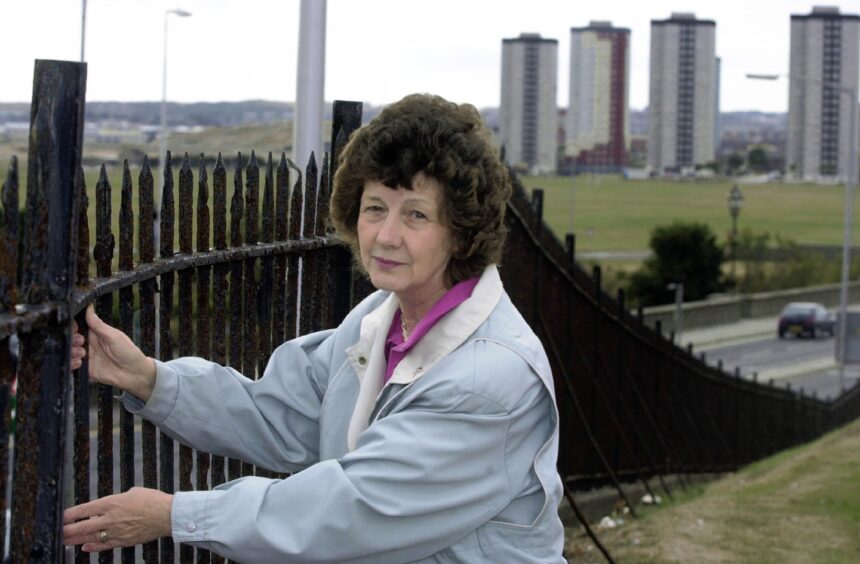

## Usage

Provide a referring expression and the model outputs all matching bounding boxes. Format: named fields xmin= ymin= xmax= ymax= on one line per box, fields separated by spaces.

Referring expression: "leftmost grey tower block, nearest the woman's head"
xmin=499 ymin=33 xmax=558 ymax=174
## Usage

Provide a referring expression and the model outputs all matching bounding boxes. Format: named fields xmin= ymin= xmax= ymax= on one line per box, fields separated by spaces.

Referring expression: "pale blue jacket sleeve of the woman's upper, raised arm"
xmin=123 ymin=331 xmax=334 ymax=472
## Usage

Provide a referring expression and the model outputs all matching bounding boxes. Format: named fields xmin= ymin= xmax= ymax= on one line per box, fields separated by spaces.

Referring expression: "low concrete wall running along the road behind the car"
xmin=643 ymin=282 xmax=860 ymax=329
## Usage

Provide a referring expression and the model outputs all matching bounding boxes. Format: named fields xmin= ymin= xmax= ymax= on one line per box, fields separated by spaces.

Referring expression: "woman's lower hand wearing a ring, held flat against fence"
xmin=63 ymin=488 xmax=173 ymax=552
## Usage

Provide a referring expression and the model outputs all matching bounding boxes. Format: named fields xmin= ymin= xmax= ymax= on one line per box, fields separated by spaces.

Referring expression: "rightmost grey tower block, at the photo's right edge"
xmin=786 ymin=6 xmax=860 ymax=180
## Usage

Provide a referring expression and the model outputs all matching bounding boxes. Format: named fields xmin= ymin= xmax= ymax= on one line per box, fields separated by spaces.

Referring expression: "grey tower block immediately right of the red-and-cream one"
xmin=648 ymin=13 xmax=719 ymax=174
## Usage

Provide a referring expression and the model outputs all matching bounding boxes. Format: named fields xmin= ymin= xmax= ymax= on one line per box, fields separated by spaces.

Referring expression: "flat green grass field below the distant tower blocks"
xmin=522 ymin=175 xmax=860 ymax=251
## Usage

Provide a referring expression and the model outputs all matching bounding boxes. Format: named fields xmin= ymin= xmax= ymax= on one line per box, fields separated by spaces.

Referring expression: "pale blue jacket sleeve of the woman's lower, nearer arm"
xmin=172 ymin=346 xmax=552 ymax=563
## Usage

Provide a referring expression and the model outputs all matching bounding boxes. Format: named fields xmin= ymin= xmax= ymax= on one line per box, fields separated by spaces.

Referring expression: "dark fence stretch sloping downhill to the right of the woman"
xmin=502 ymin=180 xmax=860 ymax=502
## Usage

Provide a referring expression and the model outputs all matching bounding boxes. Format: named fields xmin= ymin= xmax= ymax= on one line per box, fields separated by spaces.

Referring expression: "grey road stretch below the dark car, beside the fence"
xmin=706 ymin=337 xmax=860 ymax=399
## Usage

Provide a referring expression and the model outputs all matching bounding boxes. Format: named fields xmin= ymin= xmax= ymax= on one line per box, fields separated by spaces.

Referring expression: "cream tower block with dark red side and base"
xmin=565 ymin=21 xmax=630 ymax=172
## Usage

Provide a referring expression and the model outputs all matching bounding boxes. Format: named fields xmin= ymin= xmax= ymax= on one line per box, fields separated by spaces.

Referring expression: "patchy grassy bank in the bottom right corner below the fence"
xmin=567 ymin=420 xmax=860 ymax=564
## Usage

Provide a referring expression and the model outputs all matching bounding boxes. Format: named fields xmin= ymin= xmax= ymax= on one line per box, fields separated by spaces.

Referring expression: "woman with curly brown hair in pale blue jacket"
xmin=63 ymin=95 xmax=564 ymax=564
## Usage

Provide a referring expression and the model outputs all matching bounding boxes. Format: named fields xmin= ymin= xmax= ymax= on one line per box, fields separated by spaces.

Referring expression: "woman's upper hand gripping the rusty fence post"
xmin=71 ymin=305 xmax=155 ymax=402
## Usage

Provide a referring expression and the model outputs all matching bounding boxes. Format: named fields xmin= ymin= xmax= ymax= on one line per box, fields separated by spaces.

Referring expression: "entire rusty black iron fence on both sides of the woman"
xmin=5 ymin=61 xmax=860 ymax=562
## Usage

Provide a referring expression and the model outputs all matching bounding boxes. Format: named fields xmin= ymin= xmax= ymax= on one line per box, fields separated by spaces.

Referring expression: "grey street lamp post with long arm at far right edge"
xmin=747 ymin=74 xmax=857 ymax=391
